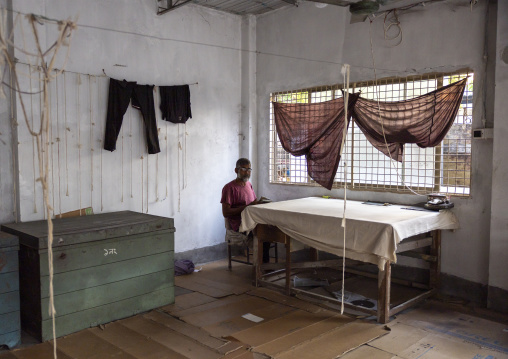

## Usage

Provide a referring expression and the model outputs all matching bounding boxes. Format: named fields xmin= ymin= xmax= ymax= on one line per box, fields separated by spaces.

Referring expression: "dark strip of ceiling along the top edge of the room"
xmin=157 ymin=0 xmax=460 ymax=18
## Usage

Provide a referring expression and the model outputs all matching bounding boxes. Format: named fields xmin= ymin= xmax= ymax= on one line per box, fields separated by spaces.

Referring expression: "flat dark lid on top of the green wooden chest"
xmin=1 ymin=211 xmax=175 ymax=249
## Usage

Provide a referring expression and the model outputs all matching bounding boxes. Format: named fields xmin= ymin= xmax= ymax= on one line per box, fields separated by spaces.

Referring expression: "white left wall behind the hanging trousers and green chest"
xmin=7 ymin=0 xmax=246 ymax=252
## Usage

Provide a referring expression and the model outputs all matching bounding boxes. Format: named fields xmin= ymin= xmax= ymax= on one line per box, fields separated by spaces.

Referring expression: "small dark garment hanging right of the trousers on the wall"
xmin=159 ymin=85 xmax=192 ymax=123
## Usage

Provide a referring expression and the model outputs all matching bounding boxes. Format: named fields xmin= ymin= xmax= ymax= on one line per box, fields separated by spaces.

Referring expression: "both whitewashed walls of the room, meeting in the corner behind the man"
xmin=0 ymin=0 xmax=508 ymax=298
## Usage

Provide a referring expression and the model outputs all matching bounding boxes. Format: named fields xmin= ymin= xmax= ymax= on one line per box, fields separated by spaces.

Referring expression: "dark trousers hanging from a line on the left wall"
xmin=104 ymin=79 xmax=160 ymax=154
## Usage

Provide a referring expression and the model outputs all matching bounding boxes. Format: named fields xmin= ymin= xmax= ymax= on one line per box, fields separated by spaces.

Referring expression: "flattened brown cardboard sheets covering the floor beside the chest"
xmin=0 ymin=266 xmax=388 ymax=359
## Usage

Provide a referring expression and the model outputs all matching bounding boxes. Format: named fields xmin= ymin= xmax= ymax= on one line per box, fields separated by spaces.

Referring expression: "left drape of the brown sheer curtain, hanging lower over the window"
xmin=273 ymin=94 xmax=358 ymax=189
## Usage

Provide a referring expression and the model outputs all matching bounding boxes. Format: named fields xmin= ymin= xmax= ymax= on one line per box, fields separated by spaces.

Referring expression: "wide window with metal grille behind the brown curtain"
xmin=269 ymin=70 xmax=474 ymax=196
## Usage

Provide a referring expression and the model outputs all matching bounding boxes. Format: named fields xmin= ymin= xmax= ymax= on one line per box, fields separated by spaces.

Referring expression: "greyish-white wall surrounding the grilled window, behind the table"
xmin=256 ymin=2 xmax=502 ymax=289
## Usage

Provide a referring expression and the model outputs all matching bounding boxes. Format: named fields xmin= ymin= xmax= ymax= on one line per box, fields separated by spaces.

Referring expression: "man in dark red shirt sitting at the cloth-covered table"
xmin=220 ymin=158 xmax=270 ymax=263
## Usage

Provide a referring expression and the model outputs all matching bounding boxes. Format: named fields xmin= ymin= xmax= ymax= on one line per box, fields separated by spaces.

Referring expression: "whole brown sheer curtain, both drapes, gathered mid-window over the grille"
xmin=273 ymin=78 xmax=467 ymax=189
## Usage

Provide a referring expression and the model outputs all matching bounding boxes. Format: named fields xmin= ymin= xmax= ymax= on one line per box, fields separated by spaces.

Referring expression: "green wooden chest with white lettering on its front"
xmin=1 ymin=211 xmax=175 ymax=341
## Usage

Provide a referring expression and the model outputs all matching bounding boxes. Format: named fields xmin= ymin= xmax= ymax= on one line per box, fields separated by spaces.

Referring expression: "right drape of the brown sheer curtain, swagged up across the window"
xmin=353 ymin=78 xmax=467 ymax=162
